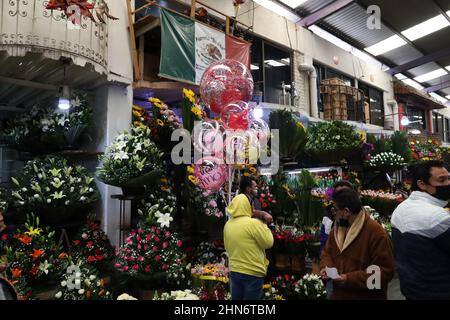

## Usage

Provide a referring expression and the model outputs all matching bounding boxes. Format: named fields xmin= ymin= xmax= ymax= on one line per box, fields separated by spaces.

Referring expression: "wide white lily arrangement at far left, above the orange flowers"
xmin=11 ymin=156 xmax=99 ymax=224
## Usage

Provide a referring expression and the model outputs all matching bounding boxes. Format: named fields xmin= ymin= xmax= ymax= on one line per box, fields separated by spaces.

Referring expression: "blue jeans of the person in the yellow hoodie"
xmin=230 ymin=272 xmax=264 ymax=300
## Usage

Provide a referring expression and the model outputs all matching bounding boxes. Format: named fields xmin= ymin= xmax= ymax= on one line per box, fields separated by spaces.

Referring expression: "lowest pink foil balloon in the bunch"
xmin=194 ymin=156 xmax=227 ymax=191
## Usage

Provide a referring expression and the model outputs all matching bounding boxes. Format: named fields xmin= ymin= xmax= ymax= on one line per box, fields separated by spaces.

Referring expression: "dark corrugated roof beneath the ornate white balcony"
xmin=0 ymin=51 xmax=106 ymax=107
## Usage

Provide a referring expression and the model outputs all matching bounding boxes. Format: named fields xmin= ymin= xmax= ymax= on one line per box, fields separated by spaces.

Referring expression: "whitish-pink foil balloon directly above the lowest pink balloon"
xmin=192 ymin=120 xmax=223 ymax=155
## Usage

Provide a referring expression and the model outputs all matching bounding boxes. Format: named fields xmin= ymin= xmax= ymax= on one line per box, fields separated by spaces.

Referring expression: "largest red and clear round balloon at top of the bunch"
xmin=200 ymin=59 xmax=253 ymax=114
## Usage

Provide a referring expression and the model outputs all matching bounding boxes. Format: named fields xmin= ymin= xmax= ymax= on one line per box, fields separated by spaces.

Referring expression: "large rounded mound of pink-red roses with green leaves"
xmin=114 ymin=225 xmax=186 ymax=282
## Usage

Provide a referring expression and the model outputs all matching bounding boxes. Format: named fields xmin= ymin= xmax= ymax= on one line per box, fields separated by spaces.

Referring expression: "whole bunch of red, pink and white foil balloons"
xmin=193 ymin=59 xmax=270 ymax=202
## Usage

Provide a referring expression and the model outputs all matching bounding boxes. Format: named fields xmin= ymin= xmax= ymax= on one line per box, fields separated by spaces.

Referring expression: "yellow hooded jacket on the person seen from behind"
xmin=223 ymin=194 xmax=273 ymax=277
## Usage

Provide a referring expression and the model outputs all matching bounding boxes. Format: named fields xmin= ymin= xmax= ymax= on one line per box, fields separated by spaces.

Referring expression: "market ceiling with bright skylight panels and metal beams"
xmin=260 ymin=0 xmax=450 ymax=103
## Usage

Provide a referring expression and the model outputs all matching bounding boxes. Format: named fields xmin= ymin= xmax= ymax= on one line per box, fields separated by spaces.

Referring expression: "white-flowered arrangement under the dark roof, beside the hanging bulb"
xmin=4 ymin=93 xmax=92 ymax=149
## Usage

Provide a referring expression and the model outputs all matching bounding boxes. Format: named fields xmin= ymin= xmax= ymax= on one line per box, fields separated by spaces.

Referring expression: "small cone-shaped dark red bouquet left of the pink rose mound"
xmin=70 ymin=219 xmax=115 ymax=268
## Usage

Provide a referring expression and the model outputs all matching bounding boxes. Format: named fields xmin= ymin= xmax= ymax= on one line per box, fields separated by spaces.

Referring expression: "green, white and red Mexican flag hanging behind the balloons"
xmin=159 ymin=9 xmax=251 ymax=85
